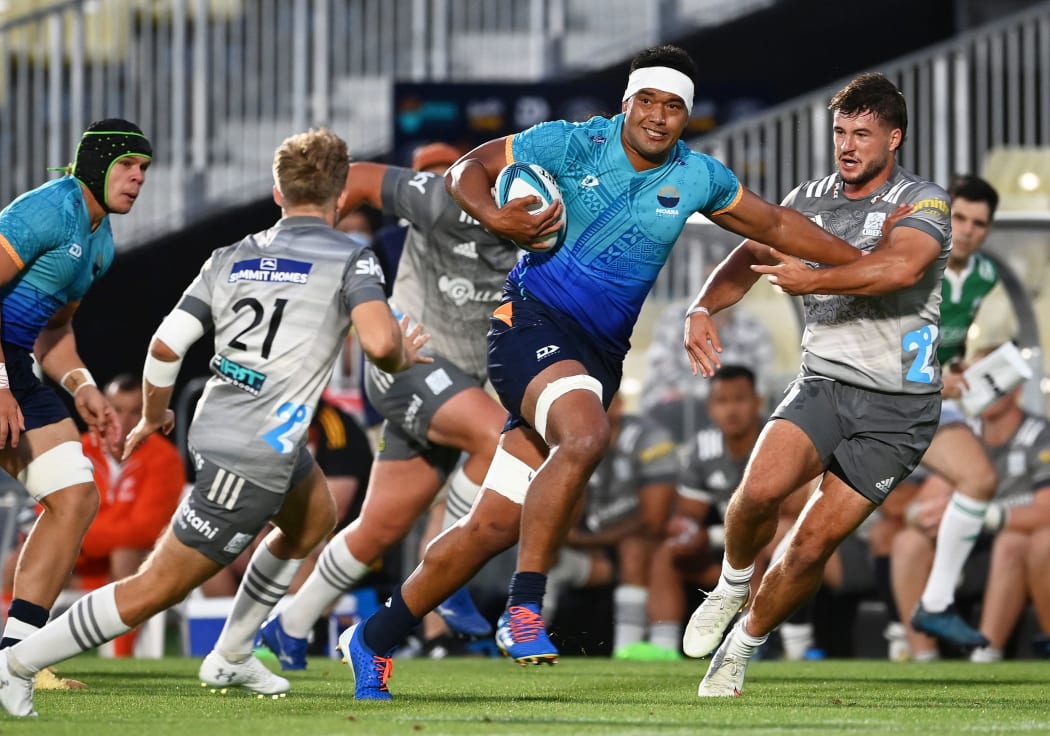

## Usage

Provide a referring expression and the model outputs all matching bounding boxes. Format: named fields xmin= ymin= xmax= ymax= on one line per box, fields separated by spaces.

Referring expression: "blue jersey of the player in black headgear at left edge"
xmin=0 ymin=176 xmax=113 ymax=351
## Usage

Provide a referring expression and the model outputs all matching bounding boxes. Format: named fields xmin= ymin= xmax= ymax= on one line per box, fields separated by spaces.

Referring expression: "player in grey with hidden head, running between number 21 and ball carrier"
xmin=254 ymin=155 xmax=521 ymax=670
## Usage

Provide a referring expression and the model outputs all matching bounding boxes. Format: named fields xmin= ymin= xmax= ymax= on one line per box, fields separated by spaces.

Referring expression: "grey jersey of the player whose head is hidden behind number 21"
xmin=382 ymin=167 xmax=522 ymax=383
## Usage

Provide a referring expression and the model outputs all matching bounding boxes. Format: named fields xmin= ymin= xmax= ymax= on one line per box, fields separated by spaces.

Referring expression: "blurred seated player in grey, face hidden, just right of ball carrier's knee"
xmin=544 ymin=394 xmax=677 ymax=657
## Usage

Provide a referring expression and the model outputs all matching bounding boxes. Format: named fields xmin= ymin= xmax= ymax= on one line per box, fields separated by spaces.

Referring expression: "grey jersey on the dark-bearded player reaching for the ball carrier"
xmin=784 ymin=166 xmax=951 ymax=394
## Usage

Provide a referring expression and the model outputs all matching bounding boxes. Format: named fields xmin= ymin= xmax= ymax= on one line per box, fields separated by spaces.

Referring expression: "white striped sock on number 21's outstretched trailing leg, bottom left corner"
xmin=7 ymin=583 xmax=131 ymax=677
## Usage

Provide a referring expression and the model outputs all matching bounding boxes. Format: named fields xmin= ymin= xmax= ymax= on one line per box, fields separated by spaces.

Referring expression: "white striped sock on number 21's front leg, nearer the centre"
xmin=215 ymin=542 xmax=302 ymax=663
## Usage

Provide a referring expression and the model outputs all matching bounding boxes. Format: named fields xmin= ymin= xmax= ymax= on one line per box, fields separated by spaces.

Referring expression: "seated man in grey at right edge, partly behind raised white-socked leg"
xmin=891 ymin=356 xmax=1050 ymax=661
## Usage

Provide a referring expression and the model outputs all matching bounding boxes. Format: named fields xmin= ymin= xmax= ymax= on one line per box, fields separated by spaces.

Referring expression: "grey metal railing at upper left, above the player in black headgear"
xmin=0 ymin=0 xmax=775 ymax=247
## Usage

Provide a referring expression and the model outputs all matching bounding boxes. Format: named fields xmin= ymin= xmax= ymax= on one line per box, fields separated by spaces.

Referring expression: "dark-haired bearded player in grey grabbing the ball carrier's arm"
xmin=683 ymin=73 xmax=951 ymax=696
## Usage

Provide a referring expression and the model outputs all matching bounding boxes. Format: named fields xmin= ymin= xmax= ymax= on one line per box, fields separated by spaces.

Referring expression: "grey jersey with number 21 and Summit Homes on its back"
xmin=176 ymin=217 xmax=385 ymax=493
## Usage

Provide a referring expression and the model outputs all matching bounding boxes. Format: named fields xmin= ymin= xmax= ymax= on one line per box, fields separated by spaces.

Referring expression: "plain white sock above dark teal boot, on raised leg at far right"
xmin=921 ymin=490 xmax=988 ymax=613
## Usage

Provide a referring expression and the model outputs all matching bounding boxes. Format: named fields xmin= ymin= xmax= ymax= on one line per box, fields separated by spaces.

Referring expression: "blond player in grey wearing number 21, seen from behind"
xmin=0 ymin=130 xmax=428 ymax=716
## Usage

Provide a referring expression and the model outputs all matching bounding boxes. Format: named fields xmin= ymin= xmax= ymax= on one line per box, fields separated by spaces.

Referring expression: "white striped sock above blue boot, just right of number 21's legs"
xmin=280 ymin=535 xmax=371 ymax=638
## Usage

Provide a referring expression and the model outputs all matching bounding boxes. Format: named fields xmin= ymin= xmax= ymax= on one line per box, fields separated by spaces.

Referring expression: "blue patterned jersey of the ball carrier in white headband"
xmin=506 ymin=114 xmax=742 ymax=355
